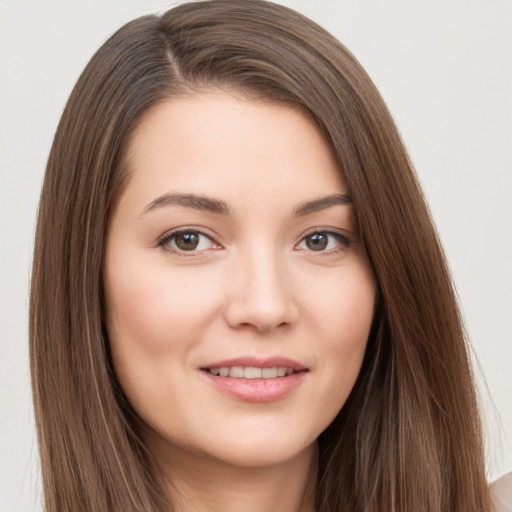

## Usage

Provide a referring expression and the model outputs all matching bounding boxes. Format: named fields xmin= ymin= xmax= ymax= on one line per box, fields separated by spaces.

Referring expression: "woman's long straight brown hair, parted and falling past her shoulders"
xmin=30 ymin=0 xmax=490 ymax=512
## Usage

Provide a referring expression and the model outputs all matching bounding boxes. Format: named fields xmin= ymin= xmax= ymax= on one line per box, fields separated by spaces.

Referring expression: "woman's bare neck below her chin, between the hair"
xmin=157 ymin=444 xmax=318 ymax=512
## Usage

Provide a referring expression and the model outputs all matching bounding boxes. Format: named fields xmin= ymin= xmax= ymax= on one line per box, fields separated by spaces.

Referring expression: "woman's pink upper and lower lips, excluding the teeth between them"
xmin=200 ymin=357 xmax=307 ymax=402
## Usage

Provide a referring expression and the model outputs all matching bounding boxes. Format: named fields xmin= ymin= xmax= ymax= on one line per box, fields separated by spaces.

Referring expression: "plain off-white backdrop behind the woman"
xmin=0 ymin=0 xmax=512 ymax=512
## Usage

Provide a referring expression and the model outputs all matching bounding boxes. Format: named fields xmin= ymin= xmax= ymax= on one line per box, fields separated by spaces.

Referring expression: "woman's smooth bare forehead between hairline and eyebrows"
xmin=120 ymin=90 xmax=345 ymax=213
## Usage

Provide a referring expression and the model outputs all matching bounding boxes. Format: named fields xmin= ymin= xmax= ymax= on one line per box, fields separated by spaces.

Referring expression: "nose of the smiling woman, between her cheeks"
xmin=225 ymin=251 xmax=298 ymax=333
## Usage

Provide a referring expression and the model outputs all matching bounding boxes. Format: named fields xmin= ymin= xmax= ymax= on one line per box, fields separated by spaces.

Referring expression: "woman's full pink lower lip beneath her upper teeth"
xmin=204 ymin=371 xmax=307 ymax=402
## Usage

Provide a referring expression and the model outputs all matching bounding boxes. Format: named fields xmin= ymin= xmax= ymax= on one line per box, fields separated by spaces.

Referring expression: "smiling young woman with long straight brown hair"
xmin=30 ymin=1 xmax=498 ymax=512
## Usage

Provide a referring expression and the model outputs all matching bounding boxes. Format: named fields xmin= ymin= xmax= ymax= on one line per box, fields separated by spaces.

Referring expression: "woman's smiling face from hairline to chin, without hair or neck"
xmin=105 ymin=90 xmax=375 ymax=466
